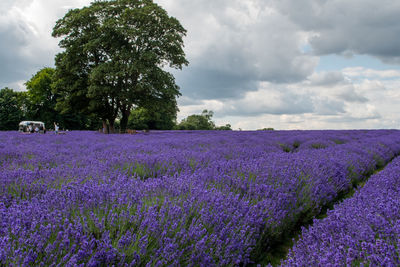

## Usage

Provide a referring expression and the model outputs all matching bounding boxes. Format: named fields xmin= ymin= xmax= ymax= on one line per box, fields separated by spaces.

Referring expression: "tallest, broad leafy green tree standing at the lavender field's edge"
xmin=53 ymin=0 xmax=188 ymax=131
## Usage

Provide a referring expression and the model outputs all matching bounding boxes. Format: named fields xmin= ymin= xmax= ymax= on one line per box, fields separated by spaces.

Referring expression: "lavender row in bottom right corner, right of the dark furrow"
xmin=282 ymin=153 xmax=400 ymax=266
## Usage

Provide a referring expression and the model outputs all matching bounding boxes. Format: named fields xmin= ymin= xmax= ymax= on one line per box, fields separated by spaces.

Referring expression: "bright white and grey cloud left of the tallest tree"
xmin=0 ymin=0 xmax=88 ymax=90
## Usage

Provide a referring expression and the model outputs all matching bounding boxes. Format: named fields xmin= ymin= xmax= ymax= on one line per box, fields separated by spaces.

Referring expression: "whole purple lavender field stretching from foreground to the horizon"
xmin=0 ymin=130 xmax=400 ymax=266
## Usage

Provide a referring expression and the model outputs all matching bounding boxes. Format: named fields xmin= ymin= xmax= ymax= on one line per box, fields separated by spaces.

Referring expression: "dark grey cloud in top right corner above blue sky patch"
xmin=273 ymin=0 xmax=400 ymax=63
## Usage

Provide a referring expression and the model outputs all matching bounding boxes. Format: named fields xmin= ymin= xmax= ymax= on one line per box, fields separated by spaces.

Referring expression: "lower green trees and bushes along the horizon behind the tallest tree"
xmin=0 ymin=85 xmax=232 ymax=132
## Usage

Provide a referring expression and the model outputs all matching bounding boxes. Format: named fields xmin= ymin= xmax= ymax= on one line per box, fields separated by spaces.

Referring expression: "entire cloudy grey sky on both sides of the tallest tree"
xmin=0 ymin=0 xmax=400 ymax=130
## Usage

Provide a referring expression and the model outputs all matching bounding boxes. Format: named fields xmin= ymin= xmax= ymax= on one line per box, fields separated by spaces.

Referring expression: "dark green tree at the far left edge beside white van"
xmin=0 ymin=87 xmax=24 ymax=131
